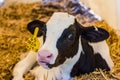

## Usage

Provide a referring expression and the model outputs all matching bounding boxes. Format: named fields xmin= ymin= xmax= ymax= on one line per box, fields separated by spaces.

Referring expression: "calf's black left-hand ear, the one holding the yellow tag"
xmin=27 ymin=20 xmax=46 ymax=37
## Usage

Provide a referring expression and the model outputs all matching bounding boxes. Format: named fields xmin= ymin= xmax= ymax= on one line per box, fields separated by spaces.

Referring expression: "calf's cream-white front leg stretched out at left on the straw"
xmin=13 ymin=51 xmax=36 ymax=80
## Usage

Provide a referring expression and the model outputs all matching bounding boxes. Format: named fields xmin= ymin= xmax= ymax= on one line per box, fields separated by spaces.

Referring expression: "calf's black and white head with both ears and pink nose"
xmin=27 ymin=12 xmax=109 ymax=68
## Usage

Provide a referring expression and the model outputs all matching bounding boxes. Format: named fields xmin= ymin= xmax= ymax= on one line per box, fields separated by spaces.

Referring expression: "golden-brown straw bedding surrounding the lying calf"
xmin=0 ymin=3 xmax=120 ymax=80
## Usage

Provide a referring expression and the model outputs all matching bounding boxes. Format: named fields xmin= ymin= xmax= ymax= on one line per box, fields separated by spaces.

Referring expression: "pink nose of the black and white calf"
xmin=38 ymin=50 xmax=53 ymax=63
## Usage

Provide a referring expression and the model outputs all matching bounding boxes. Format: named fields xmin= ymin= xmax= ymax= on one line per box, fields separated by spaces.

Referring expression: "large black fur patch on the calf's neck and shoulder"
xmin=70 ymin=38 xmax=110 ymax=77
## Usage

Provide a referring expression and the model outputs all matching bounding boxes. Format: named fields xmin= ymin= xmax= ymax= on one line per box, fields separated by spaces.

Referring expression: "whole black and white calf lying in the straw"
xmin=13 ymin=12 xmax=114 ymax=80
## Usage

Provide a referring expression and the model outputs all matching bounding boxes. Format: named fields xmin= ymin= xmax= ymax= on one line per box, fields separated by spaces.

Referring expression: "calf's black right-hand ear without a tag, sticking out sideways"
xmin=81 ymin=26 xmax=109 ymax=42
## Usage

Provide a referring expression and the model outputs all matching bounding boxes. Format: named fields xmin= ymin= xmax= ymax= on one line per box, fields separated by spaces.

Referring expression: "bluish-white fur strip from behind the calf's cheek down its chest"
xmin=55 ymin=38 xmax=82 ymax=80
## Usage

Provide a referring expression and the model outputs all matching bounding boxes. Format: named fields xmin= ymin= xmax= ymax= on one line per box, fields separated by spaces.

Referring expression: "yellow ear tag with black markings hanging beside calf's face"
xmin=27 ymin=27 xmax=41 ymax=52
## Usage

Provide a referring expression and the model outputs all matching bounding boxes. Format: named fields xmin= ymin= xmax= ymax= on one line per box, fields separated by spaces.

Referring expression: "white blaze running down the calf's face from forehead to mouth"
xmin=41 ymin=12 xmax=75 ymax=64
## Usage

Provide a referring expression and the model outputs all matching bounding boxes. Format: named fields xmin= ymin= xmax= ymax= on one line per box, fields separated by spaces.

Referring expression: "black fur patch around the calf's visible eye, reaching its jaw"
xmin=48 ymin=19 xmax=80 ymax=68
